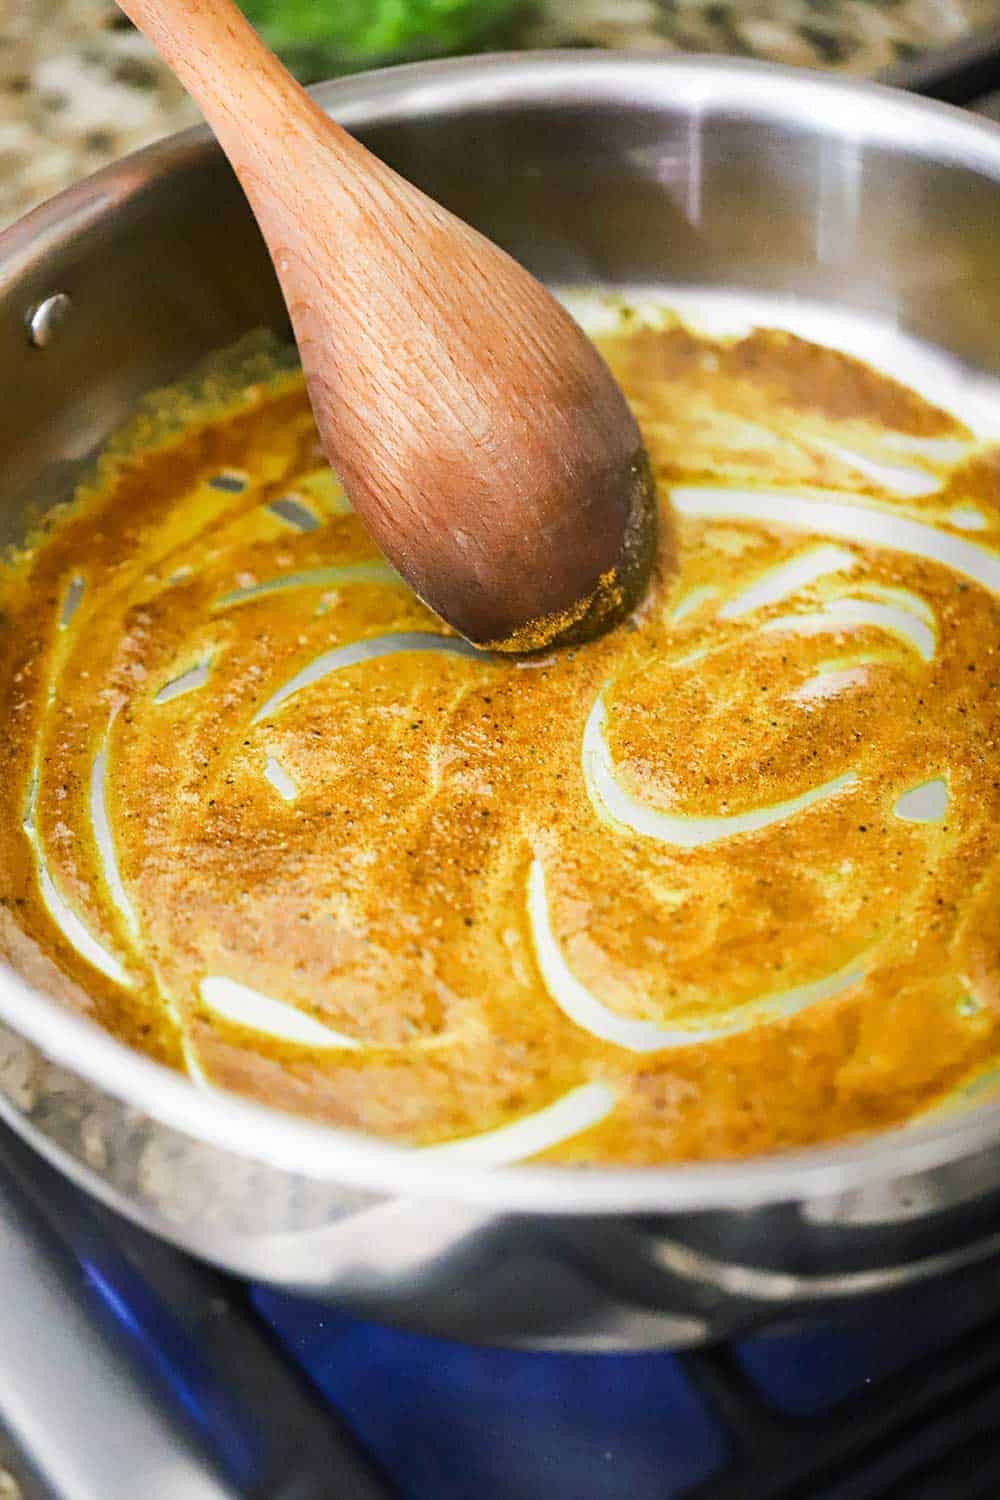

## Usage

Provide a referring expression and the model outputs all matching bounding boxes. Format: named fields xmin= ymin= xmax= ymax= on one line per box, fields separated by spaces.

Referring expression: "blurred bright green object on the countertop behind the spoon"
xmin=240 ymin=0 xmax=531 ymax=83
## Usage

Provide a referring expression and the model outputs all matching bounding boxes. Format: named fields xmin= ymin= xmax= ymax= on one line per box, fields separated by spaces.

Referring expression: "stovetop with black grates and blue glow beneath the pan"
xmin=0 ymin=52 xmax=1000 ymax=1500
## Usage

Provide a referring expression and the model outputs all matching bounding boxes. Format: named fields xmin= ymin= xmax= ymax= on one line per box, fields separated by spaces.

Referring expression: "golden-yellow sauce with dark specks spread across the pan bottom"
xmin=0 ymin=303 xmax=1000 ymax=1164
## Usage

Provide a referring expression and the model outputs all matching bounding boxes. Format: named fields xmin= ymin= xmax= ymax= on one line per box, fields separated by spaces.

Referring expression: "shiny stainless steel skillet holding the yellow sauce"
xmin=0 ymin=54 xmax=1000 ymax=1349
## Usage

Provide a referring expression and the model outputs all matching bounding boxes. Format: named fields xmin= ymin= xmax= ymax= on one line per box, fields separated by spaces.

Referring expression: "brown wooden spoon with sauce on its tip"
xmin=120 ymin=0 xmax=657 ymax=651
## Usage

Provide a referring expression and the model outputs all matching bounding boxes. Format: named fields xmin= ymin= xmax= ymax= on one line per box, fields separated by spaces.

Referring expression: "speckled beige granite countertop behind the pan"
xmin=0 ymin=0 xmax=1000 ymax=228
